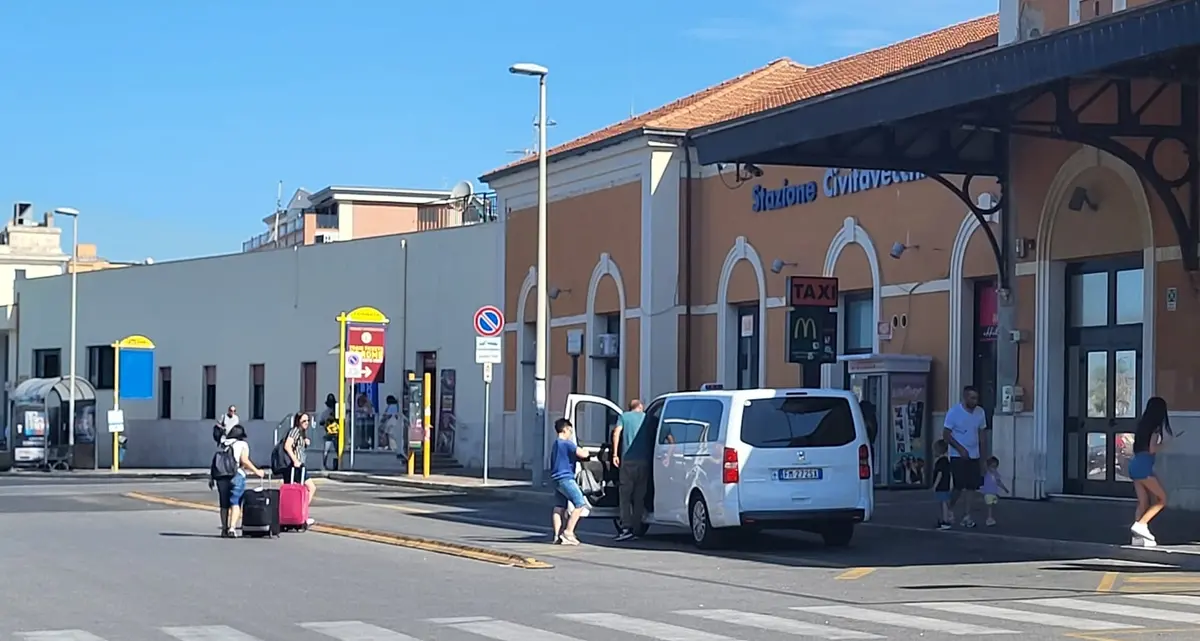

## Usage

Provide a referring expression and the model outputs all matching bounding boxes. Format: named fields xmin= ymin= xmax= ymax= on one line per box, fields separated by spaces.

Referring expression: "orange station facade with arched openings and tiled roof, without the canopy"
xmin=484 ymin=0 xmax=1200 ymax=509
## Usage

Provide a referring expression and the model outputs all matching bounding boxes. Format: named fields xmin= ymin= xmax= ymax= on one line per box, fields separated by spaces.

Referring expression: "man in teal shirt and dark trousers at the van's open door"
xmin=612 ymin=399 xmax=654 ymax=541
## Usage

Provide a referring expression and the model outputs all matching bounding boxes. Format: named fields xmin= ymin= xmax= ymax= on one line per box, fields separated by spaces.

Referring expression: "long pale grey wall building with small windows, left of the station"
xmin=7 ymin=223 xmax=504 ymax=468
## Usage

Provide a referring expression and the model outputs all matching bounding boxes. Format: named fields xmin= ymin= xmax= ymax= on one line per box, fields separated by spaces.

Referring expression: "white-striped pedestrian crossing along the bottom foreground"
xmin=11 ymin=594 xmax=1200 ymax=641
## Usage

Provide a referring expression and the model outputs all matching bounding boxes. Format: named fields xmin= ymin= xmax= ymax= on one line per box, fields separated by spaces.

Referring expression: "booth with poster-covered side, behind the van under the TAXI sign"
xmin=838 ymin=354 xmax=937 ymax=489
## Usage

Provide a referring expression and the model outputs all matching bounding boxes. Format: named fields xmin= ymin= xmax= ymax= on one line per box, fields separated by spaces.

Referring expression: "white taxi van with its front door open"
xmin=563 ymin=389 xmax=875 ymax=547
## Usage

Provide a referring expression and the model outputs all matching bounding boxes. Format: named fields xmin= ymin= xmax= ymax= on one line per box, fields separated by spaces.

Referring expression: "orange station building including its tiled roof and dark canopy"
xmin=482 ymin=0 xmax=1200 ymax=509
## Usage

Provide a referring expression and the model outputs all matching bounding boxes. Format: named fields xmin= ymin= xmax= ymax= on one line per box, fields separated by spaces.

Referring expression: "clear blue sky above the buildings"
xmin=0 ymin=0 xmax=996 ymax=260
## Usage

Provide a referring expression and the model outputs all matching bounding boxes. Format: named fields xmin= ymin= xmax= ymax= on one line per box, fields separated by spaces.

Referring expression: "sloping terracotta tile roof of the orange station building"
xmin=484 ymin=14 xmax=998 ymax=181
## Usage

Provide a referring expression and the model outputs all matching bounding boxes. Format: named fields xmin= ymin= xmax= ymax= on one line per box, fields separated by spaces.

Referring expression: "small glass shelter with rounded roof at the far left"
xmin=8 ymin=377 xmax=96 ymax=469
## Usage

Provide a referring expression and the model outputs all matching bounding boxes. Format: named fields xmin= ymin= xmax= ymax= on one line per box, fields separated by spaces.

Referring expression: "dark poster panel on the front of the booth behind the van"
xmin=888 ymin=373 xmax=929 ymax=486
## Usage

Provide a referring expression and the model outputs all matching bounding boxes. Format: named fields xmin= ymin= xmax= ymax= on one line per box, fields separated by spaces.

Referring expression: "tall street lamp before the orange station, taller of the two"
xmin=509 ymin=62 xmax=550 ymax=486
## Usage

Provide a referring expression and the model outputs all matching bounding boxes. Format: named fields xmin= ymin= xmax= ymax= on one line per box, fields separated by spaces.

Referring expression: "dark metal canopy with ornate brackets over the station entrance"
xmin=691 ymin=0 xmax=1200 ymax=272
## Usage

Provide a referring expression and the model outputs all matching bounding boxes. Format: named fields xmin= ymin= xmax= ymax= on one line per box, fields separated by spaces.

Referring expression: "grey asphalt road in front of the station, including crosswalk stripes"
xmin=0 ymin=481 xmax=1200 ymax=641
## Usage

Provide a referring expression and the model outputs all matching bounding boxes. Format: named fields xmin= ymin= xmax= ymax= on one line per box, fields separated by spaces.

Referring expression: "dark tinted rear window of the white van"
xmin=742 ymin=396 xmax=854 ymax=448
